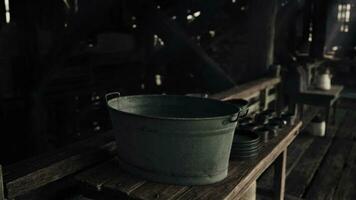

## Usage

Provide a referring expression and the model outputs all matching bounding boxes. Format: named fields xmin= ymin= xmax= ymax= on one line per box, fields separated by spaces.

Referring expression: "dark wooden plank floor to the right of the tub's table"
xmin=257 ymin=100 xmax=356 ymax=200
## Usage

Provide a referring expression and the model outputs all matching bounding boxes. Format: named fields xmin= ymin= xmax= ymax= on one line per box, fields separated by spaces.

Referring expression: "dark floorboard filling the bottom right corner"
xmin=334 ymin=142 xmax=356 ymax=199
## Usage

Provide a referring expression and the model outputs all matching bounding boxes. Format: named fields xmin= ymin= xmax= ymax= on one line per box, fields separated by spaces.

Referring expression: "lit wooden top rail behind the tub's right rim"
xmin=211 ymin=78 xmax=281 ymax=100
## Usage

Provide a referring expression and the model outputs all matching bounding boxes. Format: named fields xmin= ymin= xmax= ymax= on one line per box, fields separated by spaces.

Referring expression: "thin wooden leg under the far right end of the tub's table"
xmin=273 ymin=149 xmax=287 ymax=200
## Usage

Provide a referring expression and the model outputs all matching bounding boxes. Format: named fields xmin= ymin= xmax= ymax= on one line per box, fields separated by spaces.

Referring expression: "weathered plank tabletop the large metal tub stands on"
xmin=75 ymin=122 xmax=302 ymax=200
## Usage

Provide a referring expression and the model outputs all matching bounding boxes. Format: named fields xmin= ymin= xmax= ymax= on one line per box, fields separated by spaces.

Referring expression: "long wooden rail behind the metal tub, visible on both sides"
xmin=0 ymin=77 xmax=281 ymax=200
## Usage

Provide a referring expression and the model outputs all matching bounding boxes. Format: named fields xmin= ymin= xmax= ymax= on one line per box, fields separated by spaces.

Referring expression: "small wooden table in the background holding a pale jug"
xmin=296 ymin=85 xmax=344 ymax=133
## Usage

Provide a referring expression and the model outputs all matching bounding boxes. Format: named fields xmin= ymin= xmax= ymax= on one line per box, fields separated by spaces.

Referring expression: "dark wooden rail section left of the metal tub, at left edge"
xmin=4 ymin=132 xmax=116 ymax=198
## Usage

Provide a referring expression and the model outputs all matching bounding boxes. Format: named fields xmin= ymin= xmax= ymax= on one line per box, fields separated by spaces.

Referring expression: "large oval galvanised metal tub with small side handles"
xmin=107 ymin=93 xmax=240 ymax=185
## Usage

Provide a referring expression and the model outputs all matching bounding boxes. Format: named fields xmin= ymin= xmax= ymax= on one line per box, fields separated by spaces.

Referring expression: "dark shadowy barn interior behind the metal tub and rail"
xmin=0 ymin=0 xmax=355 ymax=164
